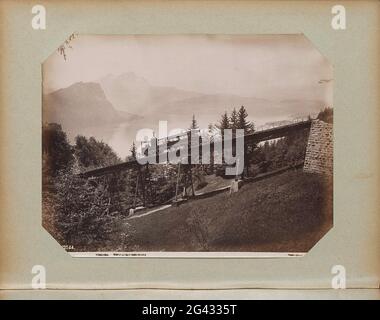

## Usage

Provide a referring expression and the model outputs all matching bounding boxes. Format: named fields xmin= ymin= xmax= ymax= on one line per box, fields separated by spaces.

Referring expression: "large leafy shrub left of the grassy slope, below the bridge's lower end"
xmin=54 ymin=171 xmax=115 ymax=251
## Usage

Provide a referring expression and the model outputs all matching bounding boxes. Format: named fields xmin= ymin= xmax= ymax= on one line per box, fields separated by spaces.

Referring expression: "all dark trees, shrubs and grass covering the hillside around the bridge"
xmin=42 ymin=106 xmax=332 ymax=251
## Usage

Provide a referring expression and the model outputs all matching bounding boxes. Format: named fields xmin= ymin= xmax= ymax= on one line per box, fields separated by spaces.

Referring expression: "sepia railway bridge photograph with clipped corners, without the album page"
xmin=41 ymin=34 xmax=333 ymax=257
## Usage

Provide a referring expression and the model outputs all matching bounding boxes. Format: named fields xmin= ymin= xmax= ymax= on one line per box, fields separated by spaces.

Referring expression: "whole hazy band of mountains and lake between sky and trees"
xmin=43 ymin=73 xmax=324 ymax=154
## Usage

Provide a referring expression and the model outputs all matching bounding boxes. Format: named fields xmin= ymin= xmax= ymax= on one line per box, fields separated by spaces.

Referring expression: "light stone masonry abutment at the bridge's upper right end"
xmin=303 ymin=120 xmax=333 ymax=174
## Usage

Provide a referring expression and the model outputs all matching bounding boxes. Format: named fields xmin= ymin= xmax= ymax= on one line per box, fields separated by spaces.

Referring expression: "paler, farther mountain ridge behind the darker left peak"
xmin=99 ymin=72 xmax=324 ymax=125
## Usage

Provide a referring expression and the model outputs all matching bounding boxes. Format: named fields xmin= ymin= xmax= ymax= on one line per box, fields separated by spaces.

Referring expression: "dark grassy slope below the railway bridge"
xmin=120 ymin=171 xmax=332 ymax=252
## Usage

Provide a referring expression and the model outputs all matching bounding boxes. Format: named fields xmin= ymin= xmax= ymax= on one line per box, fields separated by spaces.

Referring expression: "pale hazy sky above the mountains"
xmin=44 ymin=35 xmax=332 ymax=106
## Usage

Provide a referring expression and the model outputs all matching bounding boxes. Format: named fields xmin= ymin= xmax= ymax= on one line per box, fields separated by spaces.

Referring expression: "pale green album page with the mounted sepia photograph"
xmin=0 ymin=1 xmax=380 ymax=297
